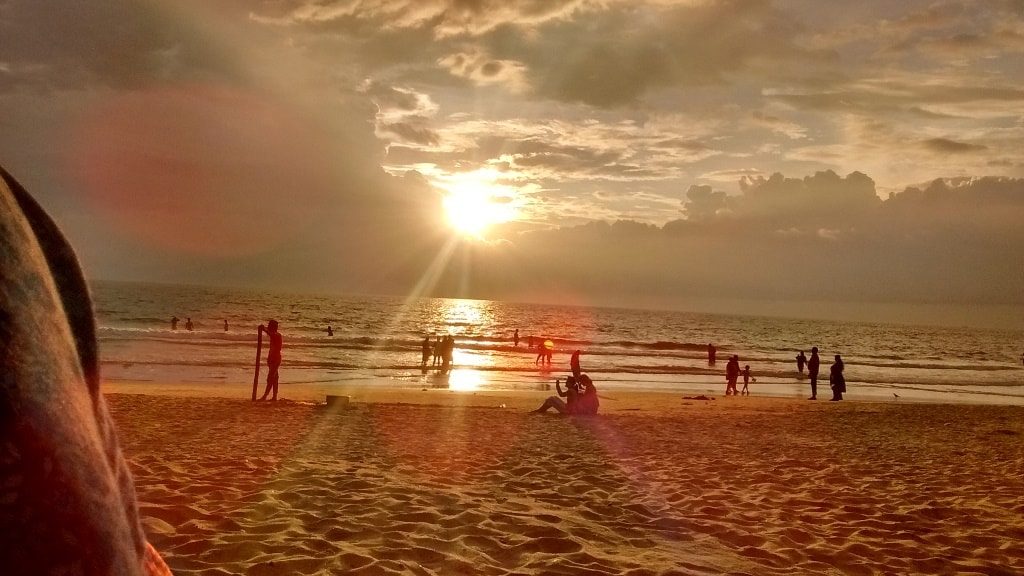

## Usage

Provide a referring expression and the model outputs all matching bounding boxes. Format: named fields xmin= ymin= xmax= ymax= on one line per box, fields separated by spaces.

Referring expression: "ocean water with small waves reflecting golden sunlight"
xmin=92 ymin=282 xmax=1024 ymax=404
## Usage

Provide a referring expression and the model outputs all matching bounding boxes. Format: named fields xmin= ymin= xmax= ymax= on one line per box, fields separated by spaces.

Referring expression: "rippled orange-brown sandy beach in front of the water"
xmin=106 ymin=384 xmax=1024 ymax=576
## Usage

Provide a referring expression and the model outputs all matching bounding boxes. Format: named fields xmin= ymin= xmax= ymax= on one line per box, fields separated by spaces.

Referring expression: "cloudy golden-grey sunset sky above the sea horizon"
xmin=0 ymin=0 xmax=1024 ymax=327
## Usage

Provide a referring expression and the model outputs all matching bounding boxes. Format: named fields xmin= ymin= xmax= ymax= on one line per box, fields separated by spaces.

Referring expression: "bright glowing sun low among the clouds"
xmin=441 ymin=170 xmax=517 ymax=239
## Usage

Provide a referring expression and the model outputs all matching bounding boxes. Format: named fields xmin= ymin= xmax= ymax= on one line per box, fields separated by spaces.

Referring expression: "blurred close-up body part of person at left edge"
xmin=0 ymin=168 xmax=170 ymax=575
